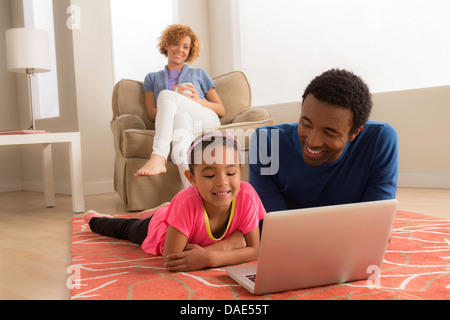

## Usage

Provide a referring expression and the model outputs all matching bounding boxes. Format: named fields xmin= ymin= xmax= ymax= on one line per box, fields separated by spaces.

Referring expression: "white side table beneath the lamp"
xmin=0 ymin=132 xmax=84 ymax=213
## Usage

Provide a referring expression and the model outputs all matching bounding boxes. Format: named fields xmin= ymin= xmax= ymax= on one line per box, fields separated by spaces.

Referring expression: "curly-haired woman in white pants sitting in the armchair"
xmin=135 ymin=24 xmax=225 ymax=187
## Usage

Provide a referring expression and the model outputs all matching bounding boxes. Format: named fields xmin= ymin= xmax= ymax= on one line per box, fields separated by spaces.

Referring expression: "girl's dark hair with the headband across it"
xmin=188 ymin=132 xmax=241 ymax=173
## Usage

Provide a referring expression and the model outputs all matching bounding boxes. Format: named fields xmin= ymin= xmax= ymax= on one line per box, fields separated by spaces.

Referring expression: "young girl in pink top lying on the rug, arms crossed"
xmin=84 ymin=133 xmax=266 ymax=271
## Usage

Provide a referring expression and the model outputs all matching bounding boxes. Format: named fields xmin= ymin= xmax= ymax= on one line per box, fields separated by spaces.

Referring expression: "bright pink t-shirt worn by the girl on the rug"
xmin=141 ymin=181 xmax=266 ymax=255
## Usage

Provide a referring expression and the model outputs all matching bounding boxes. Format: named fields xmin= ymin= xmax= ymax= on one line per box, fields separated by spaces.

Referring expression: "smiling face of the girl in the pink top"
xmin=185 ymin=147 xmax=243 ymax=214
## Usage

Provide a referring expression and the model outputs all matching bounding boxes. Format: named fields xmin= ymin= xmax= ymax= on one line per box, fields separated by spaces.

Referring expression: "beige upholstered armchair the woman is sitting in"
xmin=111 ymin=71 xmax=275 ymax=211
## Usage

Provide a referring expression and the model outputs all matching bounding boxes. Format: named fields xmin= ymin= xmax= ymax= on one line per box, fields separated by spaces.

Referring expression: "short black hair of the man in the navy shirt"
xmin=303 ymin=69 xmax=372 ymax=133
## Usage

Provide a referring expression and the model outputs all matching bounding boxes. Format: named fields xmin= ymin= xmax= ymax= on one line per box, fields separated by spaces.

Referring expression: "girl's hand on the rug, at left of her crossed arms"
xmin=164 ymin=244 xmax=210 ymax=271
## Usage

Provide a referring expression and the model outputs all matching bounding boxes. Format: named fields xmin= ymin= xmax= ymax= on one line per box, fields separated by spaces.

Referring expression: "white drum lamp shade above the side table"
xmin=6 ymin=28 xmax=51 ymax=73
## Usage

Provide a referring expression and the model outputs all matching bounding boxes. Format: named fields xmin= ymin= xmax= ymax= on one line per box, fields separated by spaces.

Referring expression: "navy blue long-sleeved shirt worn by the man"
xmin=249 ymin=121 xmax=398 ymax=212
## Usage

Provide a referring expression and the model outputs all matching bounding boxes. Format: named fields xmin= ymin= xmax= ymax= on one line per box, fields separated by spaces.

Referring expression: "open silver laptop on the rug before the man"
xmin=226 ymin=199 xmax=397 ymax=295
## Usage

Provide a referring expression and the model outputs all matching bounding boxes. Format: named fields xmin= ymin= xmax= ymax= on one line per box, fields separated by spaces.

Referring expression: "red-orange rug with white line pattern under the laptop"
xmin=68 ymin=211 xmax=450 ymax=300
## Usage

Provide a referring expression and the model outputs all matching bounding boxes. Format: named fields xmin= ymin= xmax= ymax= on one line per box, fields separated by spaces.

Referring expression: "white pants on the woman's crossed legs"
xmin=153 ymin=90 xmax=220 ymax=187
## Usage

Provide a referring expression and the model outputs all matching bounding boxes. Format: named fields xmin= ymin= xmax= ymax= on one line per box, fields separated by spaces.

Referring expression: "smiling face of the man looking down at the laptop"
xmin=298 ymin=94 xmax=364 ymax=166
